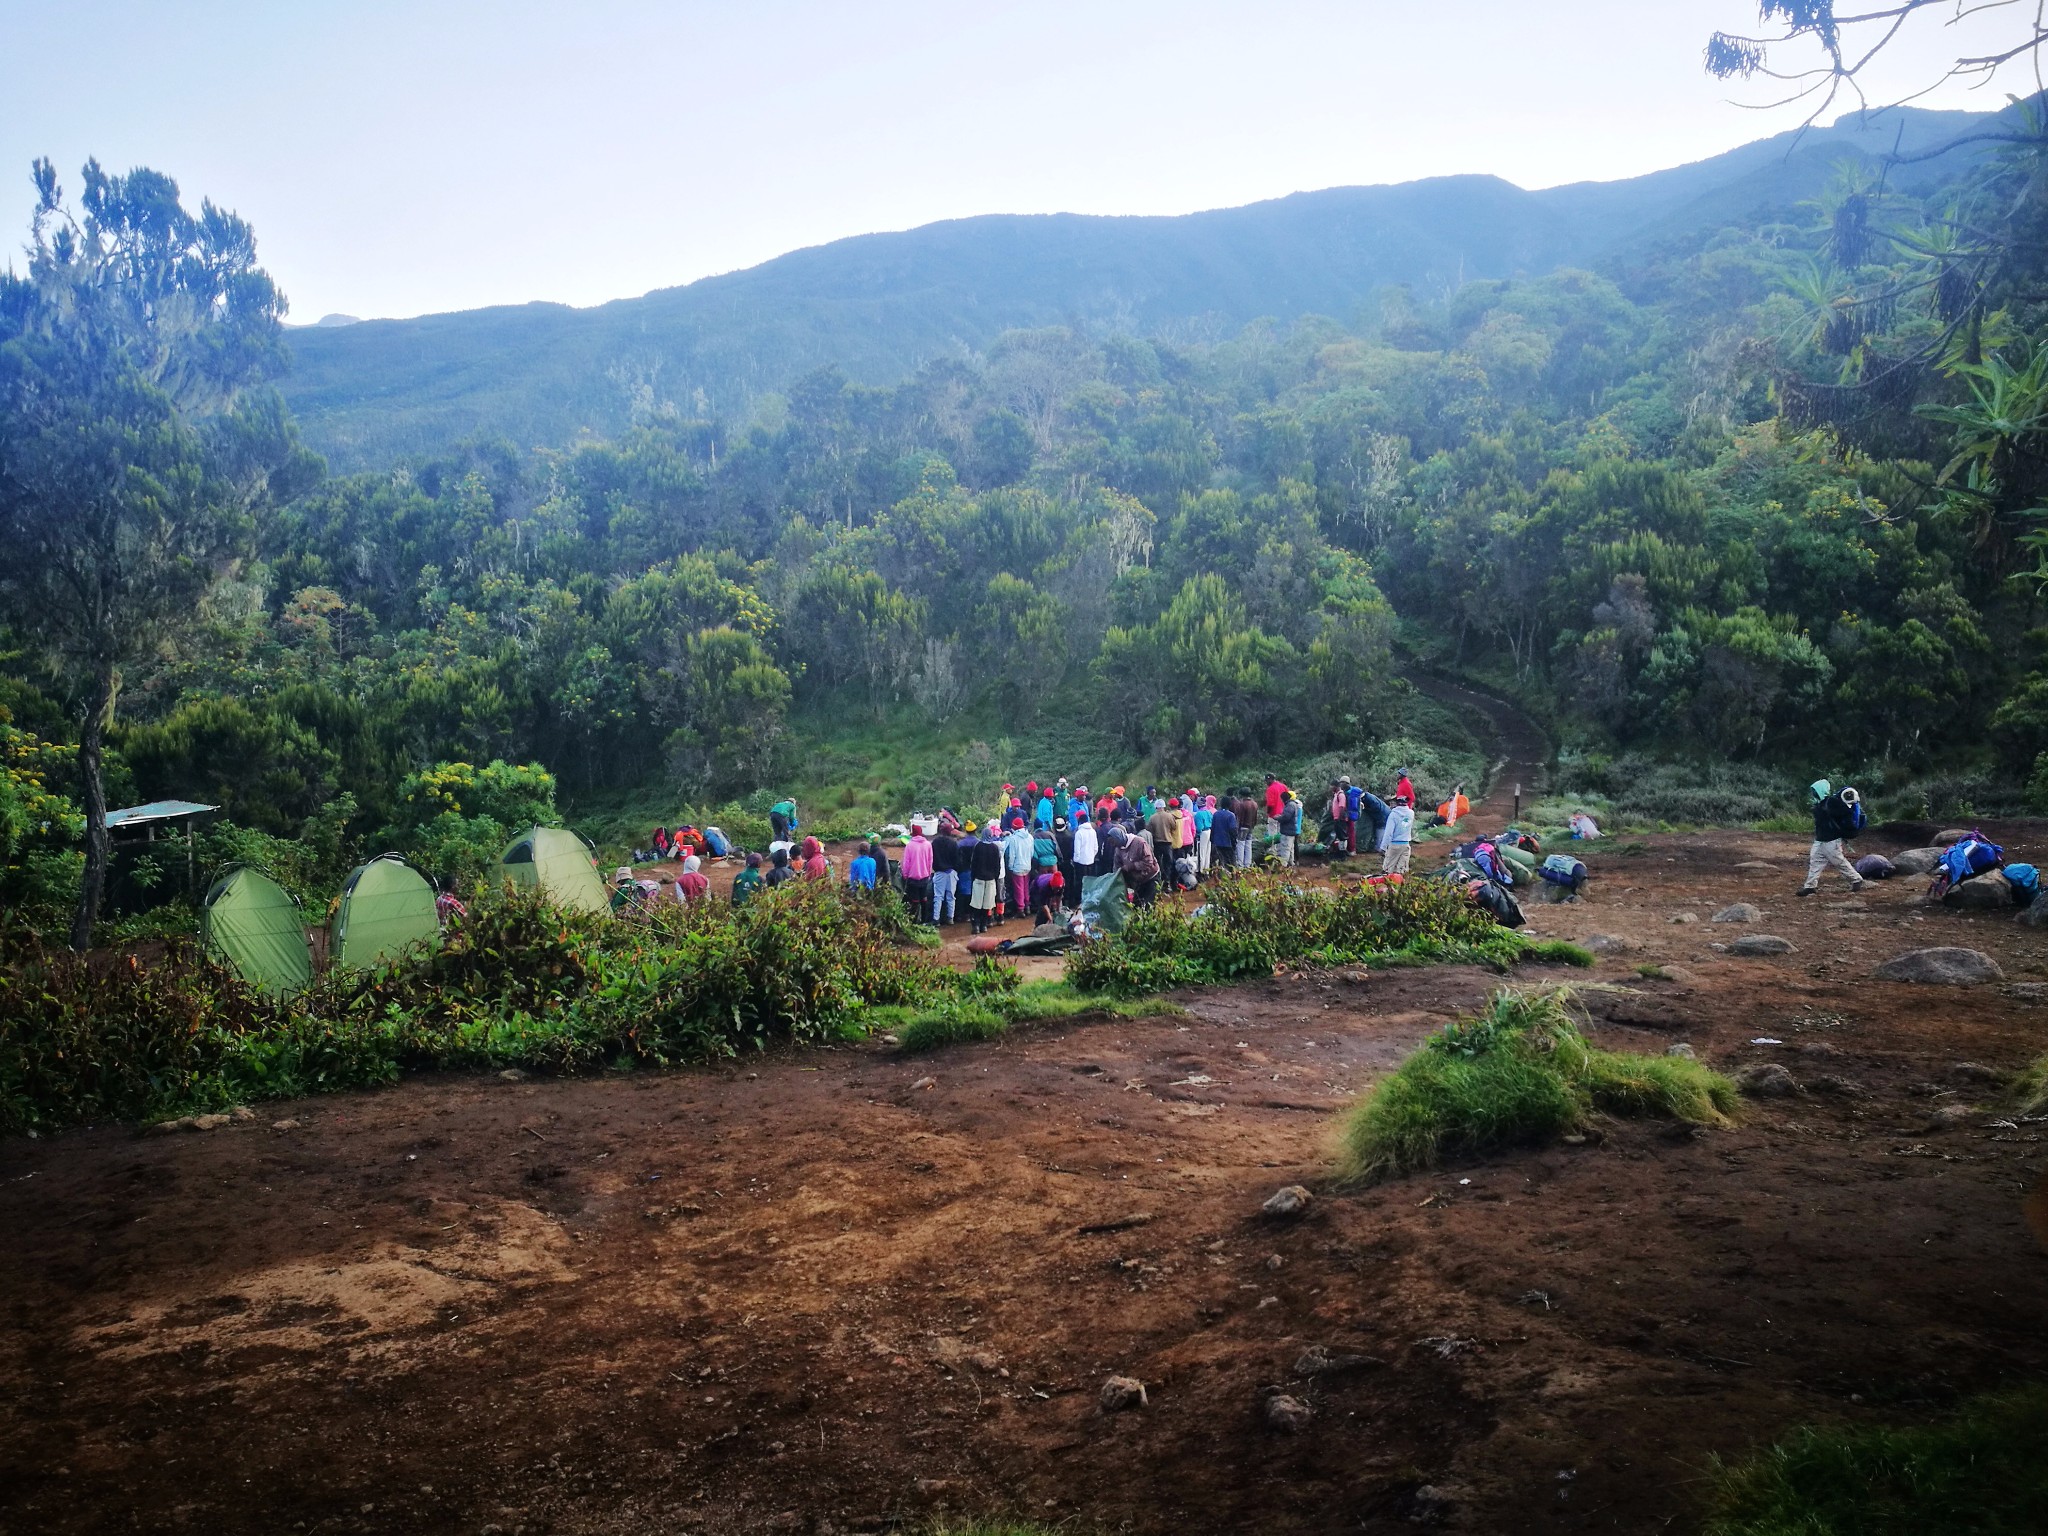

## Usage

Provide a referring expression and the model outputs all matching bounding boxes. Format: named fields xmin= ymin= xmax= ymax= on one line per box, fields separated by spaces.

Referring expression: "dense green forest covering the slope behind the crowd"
xmin=0 ymin=96 xmax=2048 ymax=946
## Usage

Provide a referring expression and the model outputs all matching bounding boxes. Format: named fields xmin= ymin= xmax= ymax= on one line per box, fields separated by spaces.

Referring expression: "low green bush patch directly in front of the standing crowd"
xmin=1067 ymin=870 xmax=1567 ymax=997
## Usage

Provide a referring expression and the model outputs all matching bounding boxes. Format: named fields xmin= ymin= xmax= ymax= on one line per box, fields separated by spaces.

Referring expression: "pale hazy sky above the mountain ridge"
xmin=0 ymin=0 xmax=2032 ymax=322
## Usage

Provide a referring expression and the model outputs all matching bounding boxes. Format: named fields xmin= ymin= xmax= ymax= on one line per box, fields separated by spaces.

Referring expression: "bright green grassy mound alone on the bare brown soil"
xmin=1339 ymin=989 xmax=1737 ymax=1182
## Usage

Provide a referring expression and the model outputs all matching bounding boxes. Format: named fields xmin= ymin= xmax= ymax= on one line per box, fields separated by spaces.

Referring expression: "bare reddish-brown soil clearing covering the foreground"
xmin=0 ymin=829 xmax=2048 ymax=1534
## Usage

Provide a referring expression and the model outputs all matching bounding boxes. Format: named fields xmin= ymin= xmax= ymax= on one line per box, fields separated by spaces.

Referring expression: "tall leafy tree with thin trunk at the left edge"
xmin=0 ymin=160 xmax=315 ymax=948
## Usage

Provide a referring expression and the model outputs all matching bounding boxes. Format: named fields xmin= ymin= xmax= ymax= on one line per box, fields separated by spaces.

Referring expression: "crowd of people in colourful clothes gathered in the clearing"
xmin=612 ymin=770 xmax=1441 ymax=934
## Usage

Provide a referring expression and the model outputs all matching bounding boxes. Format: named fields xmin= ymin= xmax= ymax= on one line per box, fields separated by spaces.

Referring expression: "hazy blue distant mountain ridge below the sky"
xmin=283 ymin=109 xmax=1985 ymax=469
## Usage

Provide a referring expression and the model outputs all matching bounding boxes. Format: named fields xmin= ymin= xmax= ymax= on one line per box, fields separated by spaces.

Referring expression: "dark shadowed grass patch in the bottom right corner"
xmin=1704 ymin=1386 xmax=2048 ymax=1536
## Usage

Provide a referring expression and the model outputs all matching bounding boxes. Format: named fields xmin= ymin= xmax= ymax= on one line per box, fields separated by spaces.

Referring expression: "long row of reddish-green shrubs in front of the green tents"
xmin=0 ymin=883 xmax=961 ymax=1130
